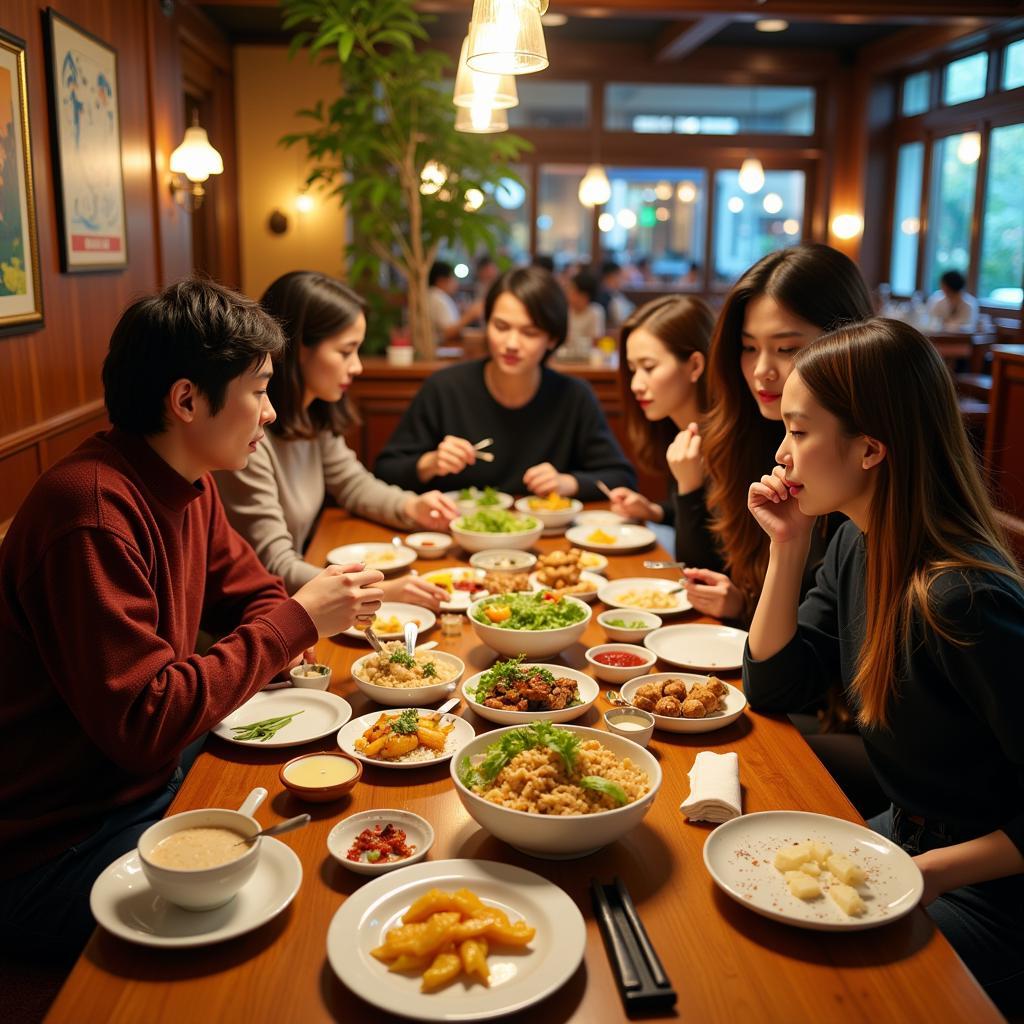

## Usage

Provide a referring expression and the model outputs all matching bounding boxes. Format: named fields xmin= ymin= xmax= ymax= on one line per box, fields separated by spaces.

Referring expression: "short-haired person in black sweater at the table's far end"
xmin=375 ymin=266 xmax=635 ymax=501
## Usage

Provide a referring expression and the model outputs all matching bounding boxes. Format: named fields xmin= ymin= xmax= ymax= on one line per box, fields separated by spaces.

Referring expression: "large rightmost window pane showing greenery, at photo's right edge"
xmin=978 ymin=124 xmax=1024 ymax=306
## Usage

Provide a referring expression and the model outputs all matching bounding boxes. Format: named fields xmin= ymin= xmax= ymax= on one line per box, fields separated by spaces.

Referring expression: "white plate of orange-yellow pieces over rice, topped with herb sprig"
xmin=338 ymin=708 xmax=476 ymax=768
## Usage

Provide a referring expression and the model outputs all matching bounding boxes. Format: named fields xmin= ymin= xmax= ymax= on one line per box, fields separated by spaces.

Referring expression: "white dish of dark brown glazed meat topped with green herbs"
xmin=462 ymin=656 xmax=600 ymax=725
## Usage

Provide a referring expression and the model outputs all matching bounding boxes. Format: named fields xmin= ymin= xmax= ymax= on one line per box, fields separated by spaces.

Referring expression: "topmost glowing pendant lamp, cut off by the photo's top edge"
xmin=466 ymin=0 xmax=548 ymax=75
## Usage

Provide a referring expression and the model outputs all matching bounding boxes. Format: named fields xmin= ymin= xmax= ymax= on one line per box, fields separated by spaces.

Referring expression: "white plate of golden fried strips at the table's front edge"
xmin=327 ymin=860 xmax=587 ymax=1021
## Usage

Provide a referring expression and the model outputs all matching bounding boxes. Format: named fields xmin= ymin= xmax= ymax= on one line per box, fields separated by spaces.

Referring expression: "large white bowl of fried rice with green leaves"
xmin=451 ymin=722 xmax=662 ymax=860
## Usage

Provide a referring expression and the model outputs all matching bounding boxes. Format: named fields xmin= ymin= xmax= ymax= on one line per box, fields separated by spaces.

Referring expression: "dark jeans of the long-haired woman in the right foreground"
xmin=867 ymin=807 xmax=1024 ymax=1014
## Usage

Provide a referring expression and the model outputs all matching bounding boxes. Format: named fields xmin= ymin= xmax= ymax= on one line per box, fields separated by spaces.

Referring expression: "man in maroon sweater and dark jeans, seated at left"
xmin=0 ymin=280 xmax=383 ymax=955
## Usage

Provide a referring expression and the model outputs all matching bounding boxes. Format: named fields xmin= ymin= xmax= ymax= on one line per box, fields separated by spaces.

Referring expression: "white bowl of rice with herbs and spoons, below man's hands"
xmin=352 ymin=641 xmax=466 ymax=708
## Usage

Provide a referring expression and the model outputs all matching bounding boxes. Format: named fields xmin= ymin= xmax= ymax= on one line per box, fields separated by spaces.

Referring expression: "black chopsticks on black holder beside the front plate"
xmin=590 ymin=877 xmax=676 ymax=1013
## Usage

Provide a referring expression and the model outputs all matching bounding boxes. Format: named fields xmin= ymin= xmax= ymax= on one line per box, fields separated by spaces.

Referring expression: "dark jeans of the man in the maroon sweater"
xmin=0 ymin=734 xmax=206 ymax=965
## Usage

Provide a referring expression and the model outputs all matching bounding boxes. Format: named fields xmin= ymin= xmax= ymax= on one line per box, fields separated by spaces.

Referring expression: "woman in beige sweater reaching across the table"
xmin=215 ymin=270 xmax=457 ymax=608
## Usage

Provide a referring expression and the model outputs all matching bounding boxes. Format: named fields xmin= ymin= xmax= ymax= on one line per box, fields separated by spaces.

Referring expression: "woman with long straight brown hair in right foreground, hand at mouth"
xmin=743 ymin=317 xmax=1024 ymax=1012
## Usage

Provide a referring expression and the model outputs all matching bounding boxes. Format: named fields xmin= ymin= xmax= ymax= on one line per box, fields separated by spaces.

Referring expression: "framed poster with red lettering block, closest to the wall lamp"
xmin=46 ymin=7 xmax=128 ymax=272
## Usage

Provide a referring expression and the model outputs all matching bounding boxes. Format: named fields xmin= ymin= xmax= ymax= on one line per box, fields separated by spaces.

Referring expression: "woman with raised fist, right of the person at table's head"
xmin=611 ymin=295 xmax=715 ymax=561
